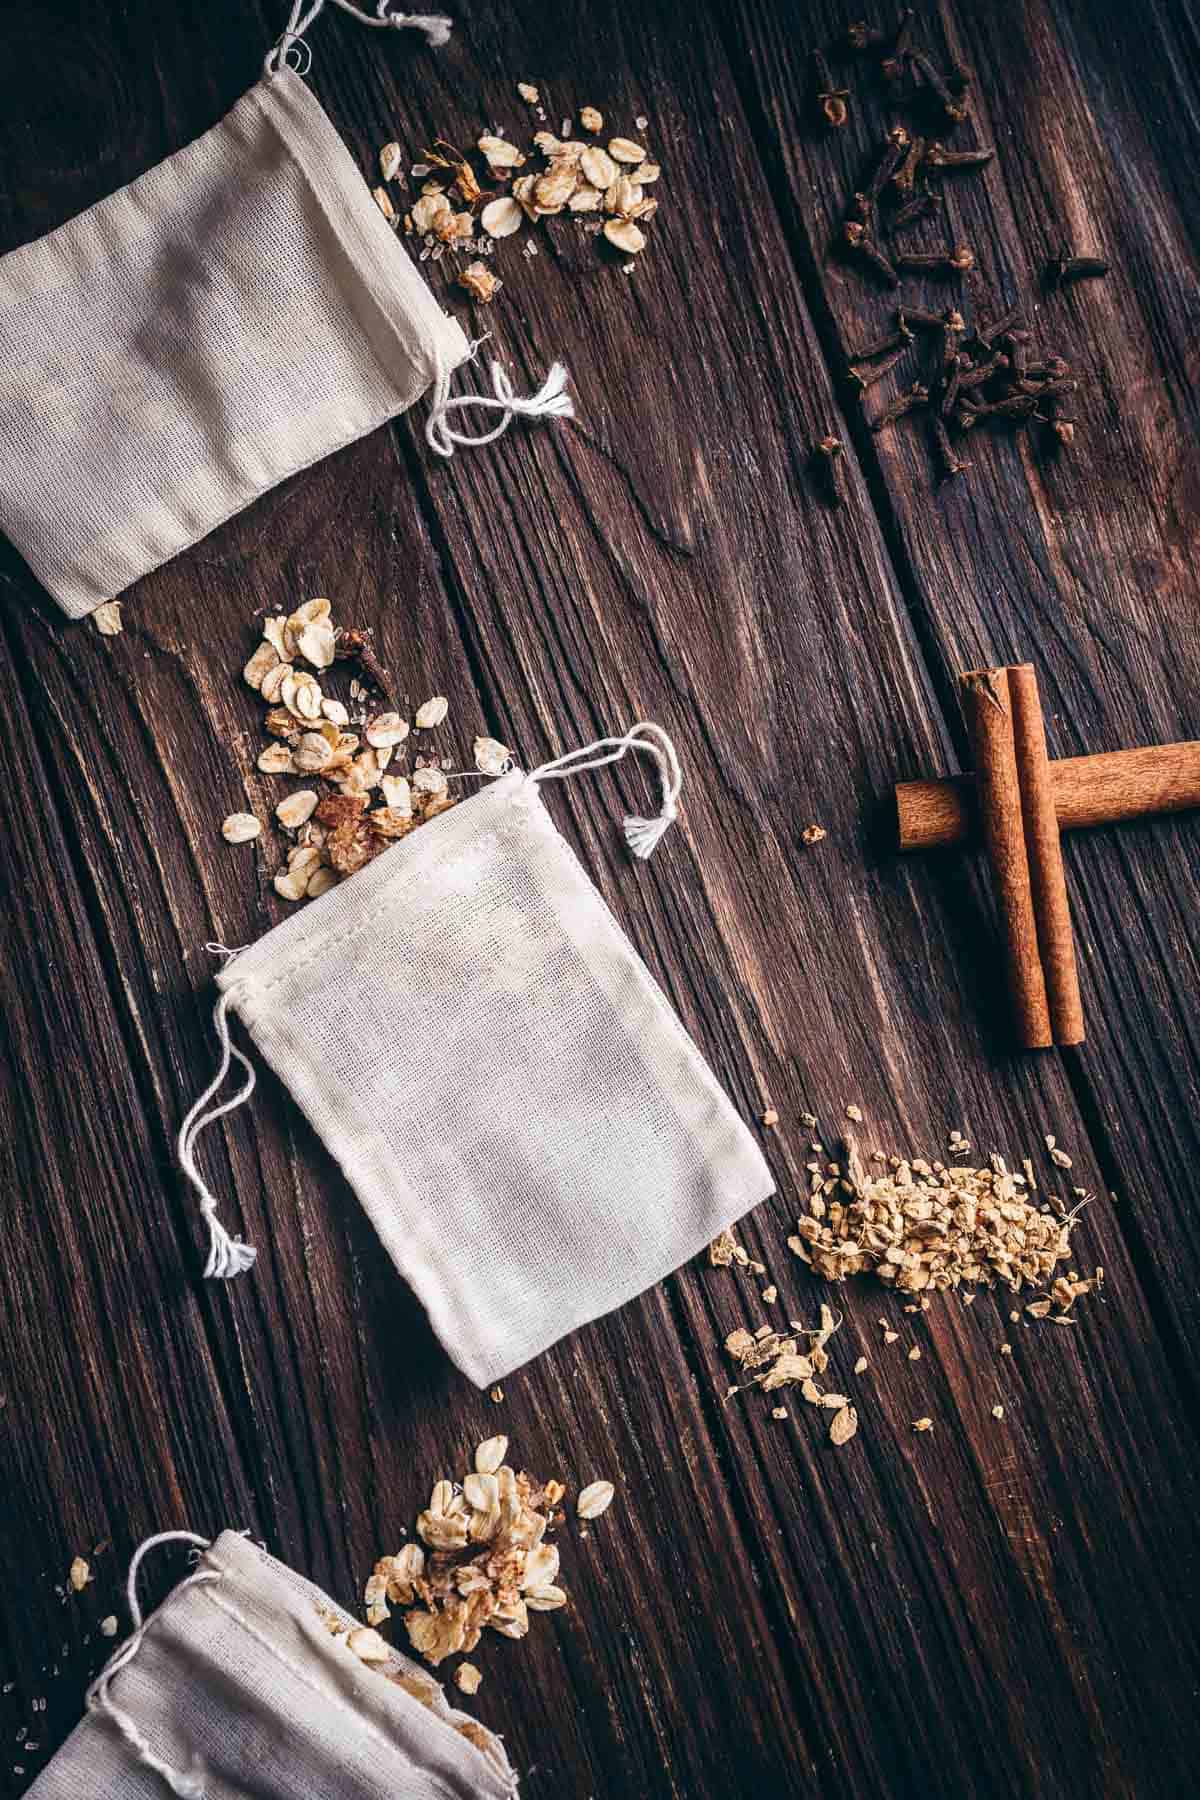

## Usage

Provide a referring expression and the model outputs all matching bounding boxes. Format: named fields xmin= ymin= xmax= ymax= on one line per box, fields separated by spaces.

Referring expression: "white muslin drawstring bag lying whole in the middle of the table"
xmin=180 ymin=724 xmax=774 ymax=1388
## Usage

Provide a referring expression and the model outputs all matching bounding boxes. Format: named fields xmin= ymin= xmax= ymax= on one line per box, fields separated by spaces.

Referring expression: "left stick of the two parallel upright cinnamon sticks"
xmin=963 ymin=670 xmax=1054 ymax=1049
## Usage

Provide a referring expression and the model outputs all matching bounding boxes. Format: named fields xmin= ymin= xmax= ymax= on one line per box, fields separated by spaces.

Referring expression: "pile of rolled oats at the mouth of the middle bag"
xmin=221 ymin=598 xmax=509 ymax=900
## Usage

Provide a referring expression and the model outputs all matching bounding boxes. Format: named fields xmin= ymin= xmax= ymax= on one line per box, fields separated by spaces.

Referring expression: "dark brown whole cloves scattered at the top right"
xmin=811 ymin=9 xmax=1106 ymax=504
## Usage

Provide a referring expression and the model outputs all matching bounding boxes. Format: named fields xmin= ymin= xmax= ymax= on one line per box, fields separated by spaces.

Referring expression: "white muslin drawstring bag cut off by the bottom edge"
xmin=29 ymin=1532 xmax=516 ymax=1800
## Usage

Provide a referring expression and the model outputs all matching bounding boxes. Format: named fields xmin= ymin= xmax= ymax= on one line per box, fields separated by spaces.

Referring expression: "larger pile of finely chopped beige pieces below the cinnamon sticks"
xmin=788 ymin=1132 xmax=1103 ymax=1325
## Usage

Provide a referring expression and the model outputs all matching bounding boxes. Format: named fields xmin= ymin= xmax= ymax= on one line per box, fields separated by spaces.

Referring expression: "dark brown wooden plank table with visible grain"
xmin=0 ymin=0 xmax=1200 ymax=1800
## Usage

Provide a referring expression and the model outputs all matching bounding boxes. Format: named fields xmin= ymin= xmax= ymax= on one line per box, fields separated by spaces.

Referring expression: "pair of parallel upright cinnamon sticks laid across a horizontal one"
xmin=963 ymin=662 xmax=1085 ymax=1049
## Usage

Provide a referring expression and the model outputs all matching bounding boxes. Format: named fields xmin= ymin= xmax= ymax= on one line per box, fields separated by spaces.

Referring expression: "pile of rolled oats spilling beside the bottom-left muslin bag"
xmin=363 ymin=1436 xmax=613 ymax=1670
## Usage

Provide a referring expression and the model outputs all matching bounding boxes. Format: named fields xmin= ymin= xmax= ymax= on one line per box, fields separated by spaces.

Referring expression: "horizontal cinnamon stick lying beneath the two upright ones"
xmin=896 ymin=742 xmax=1200 ymax=850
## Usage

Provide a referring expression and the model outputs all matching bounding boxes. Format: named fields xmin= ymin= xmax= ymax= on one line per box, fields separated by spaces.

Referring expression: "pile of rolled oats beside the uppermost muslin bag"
xmin=374 ymin=81 xmax=662 ymax=301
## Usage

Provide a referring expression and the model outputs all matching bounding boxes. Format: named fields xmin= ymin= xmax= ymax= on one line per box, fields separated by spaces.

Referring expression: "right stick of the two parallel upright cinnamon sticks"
xmin=1006 ymin=662 xmax=1085 ymax=1044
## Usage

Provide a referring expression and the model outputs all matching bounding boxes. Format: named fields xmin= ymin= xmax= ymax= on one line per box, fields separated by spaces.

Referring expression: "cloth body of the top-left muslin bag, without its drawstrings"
xmin=0 ymin=68 xmax=468 ymax=617
